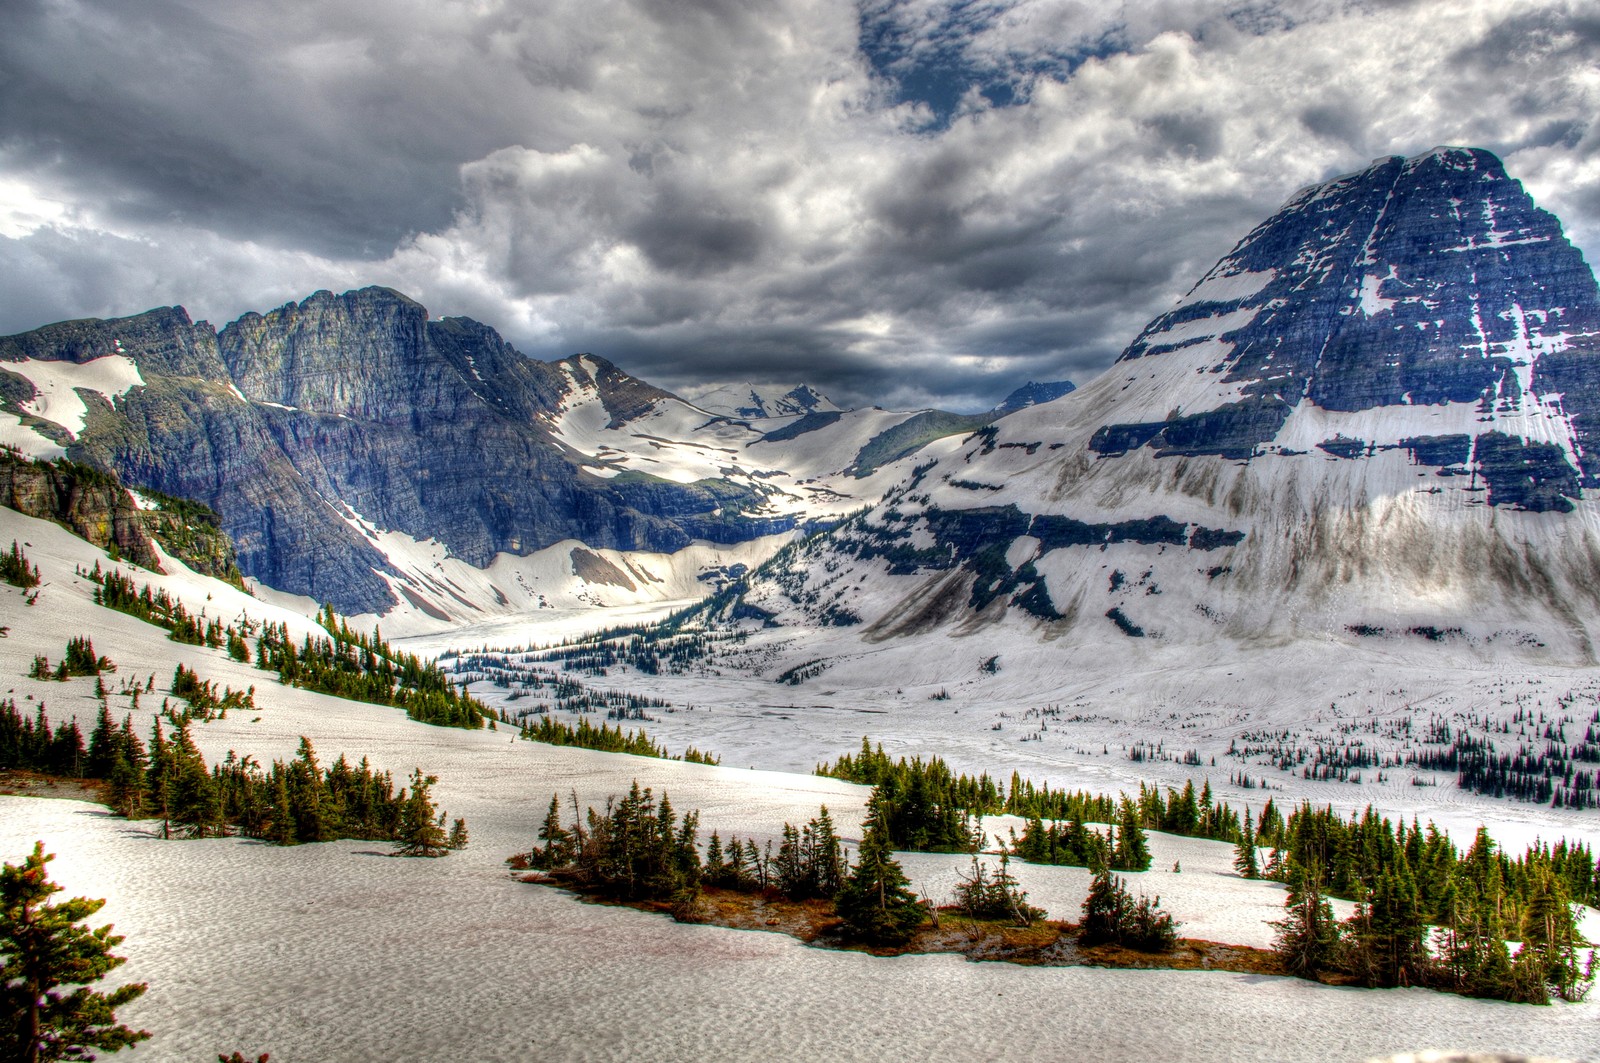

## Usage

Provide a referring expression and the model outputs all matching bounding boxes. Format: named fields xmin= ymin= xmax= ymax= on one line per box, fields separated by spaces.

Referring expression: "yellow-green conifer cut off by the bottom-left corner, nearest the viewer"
xmin=0 ymin=842 xmax=150 ymax=1063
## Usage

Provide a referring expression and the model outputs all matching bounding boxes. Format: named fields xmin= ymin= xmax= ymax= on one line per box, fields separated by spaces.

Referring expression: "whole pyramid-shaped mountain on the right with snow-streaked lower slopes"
xmin=729 ymin=149 xmax=1600 ymax=663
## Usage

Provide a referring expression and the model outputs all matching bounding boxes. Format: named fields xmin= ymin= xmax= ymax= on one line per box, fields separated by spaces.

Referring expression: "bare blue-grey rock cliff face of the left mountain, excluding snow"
xmin=0 ymin=288 xmax=792 ymax=613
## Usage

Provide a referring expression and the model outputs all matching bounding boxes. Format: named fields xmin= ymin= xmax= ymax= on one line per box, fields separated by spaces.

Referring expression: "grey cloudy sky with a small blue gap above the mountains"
xmin=0 ymin=0 xmax=1600 ymax=408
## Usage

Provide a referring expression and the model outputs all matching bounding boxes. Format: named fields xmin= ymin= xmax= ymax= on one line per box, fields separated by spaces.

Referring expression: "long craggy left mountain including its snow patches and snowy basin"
xmin=0 ymin=288 xmax=985 ymax=634
